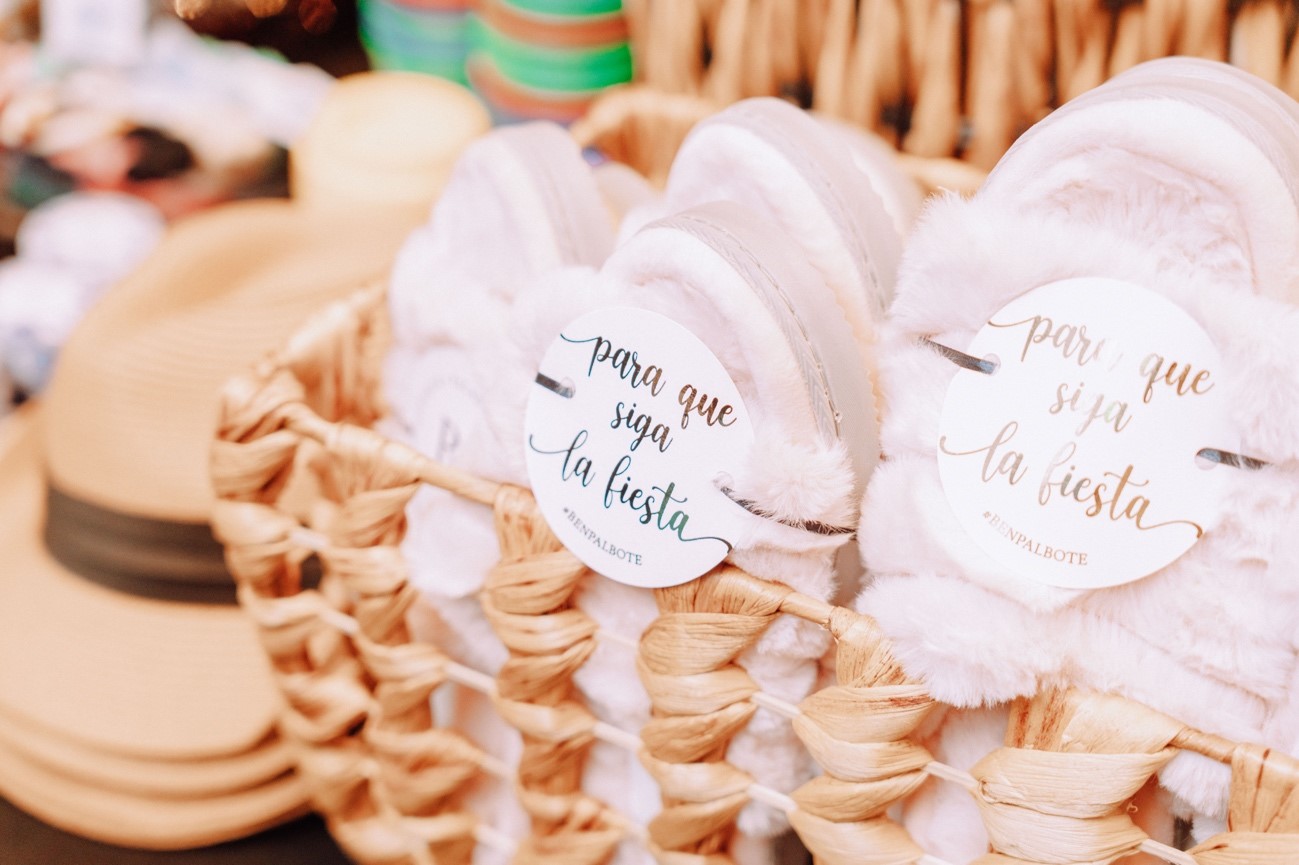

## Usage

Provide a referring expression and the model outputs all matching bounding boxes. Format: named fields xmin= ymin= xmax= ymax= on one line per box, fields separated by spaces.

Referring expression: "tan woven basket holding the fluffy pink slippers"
xmin=213 ymin=288 xmax=1299 ymax=865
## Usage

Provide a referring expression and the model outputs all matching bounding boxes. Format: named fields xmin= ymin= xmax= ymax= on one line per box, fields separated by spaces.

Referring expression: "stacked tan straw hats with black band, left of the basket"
xmin=0 ymin=70 xmax=482 ymax=846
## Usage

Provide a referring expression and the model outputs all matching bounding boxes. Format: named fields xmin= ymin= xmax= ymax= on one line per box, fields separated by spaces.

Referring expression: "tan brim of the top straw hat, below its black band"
xmin=0 ymin=409 xmax=281 ymax=758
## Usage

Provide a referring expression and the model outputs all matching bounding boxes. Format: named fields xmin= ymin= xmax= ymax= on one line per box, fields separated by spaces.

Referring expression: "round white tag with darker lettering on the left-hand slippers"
xmin=523 ymin=307 xmax=753 ymax=587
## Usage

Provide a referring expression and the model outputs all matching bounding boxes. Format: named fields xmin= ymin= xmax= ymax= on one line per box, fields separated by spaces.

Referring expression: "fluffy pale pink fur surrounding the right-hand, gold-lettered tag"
xmin=859 ymin=109 xmax=1299 ymax=836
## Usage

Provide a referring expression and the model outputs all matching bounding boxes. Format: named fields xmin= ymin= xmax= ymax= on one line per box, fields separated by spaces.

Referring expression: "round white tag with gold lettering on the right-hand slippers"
xmin=938 ymin=278 xmax=1237 ymax=588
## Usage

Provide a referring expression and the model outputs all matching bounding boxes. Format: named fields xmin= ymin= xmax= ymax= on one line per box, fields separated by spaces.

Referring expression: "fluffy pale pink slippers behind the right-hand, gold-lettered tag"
xmin=856 ymin=58 xmax=1299 ymax=861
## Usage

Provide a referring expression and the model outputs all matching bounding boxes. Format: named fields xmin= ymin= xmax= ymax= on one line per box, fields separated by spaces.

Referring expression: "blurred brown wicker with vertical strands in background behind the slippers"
xmin=631 ymin=0 xmax=1299 ymax=170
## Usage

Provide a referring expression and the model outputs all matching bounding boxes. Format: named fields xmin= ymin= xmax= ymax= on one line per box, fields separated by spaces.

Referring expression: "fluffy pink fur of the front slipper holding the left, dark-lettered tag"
xmin=501 ymin=209 xmax=853 ymax=836
